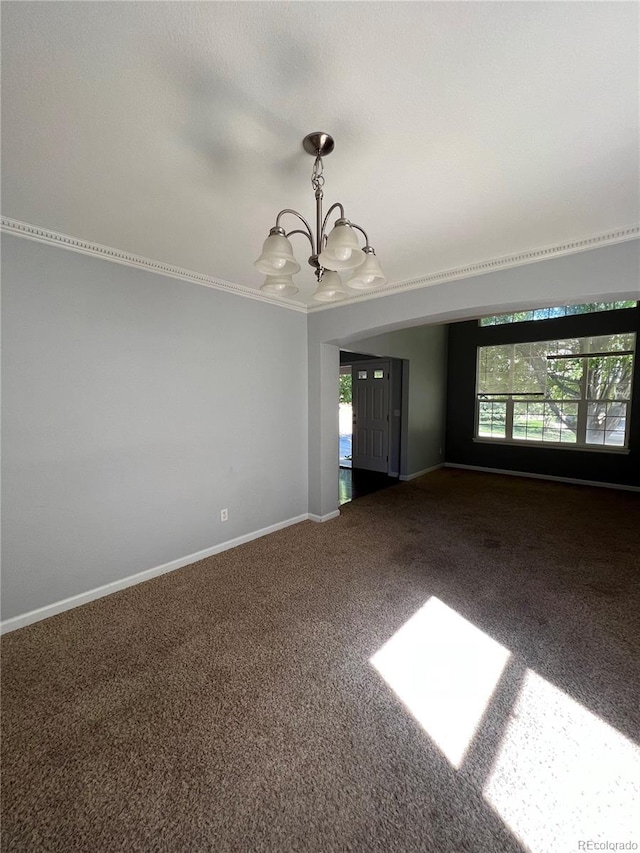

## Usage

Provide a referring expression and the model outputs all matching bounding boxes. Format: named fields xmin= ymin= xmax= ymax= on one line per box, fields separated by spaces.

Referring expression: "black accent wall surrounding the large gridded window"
xmin=446 ymin=308 xmax=640 ymax=486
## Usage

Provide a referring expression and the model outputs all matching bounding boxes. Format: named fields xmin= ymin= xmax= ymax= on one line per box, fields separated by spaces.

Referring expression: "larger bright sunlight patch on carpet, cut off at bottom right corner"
xmin=483 ymin=670 xmax=640 ymax=853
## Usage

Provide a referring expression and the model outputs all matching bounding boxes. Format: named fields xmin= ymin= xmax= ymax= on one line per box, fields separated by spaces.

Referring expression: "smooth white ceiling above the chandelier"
xmin=2 ymin=2 xmax=640 ymax=303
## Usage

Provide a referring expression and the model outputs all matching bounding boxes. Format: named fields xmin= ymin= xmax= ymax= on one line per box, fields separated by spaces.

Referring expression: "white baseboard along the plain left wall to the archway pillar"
xmin=0 ymin=510 xmax=310 ymax=634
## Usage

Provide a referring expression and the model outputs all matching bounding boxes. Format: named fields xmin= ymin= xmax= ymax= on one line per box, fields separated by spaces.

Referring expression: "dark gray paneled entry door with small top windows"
xmin=351 ymin=359 xmax=389 ymax=474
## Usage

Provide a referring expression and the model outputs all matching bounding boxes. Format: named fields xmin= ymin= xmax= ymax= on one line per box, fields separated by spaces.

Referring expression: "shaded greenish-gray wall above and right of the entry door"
xmin=348 ymin=326 xmax=447 ymax=475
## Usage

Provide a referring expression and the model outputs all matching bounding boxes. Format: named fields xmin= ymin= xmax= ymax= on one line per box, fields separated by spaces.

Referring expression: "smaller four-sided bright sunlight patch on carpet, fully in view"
xmin=370 ymin=596 xmax=510 ymax=767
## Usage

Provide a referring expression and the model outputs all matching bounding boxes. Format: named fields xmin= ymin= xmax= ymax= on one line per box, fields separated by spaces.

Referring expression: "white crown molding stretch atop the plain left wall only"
xmin=0 ymin=216 xmax=307 ymax=314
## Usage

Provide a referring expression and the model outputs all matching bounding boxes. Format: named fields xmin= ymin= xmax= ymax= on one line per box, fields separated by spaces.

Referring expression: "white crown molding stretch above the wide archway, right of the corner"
xmin=308 ymin=225 xmax=640 ymax=313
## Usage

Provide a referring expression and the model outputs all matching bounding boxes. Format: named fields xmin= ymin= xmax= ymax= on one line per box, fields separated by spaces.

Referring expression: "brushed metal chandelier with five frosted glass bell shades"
xmin=254 ymin=132 xmax=386 ymax=302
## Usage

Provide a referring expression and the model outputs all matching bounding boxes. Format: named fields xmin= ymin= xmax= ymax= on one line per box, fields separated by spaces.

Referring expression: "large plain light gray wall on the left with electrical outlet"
xmin=2 ymin=235 xmax=310 ymax=618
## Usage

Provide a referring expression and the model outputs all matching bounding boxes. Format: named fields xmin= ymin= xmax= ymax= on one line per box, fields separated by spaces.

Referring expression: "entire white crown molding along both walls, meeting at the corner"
xmin=0 ymin=216 xmax=640 ymax=314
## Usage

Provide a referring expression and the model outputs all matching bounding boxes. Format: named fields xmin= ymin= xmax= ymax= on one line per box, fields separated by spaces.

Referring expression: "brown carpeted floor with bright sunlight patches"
xmin=2 ymin=469 xmax=640 ymax=853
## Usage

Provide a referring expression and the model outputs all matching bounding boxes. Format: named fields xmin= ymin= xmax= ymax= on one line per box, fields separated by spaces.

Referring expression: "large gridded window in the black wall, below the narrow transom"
xmin=476 ymin=332 xmax=636 ymax=449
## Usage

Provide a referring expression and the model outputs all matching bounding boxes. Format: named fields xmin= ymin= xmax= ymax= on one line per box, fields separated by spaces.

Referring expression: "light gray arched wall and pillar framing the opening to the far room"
xmin=308 ymin=240 xmax=640 ymax=516
